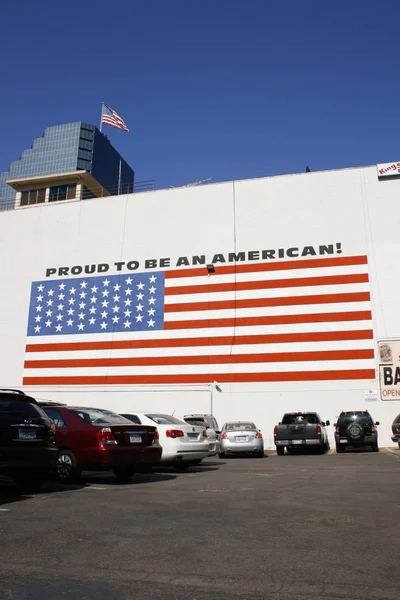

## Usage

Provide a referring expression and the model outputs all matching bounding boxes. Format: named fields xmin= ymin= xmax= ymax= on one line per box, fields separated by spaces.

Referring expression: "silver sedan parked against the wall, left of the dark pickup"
xmin=219 ymin=421 xmax=264 ymax=458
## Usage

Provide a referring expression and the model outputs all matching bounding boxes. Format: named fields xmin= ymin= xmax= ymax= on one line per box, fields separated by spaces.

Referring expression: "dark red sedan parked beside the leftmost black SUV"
xmin=39 ymin=402 xmax=162 ymax=482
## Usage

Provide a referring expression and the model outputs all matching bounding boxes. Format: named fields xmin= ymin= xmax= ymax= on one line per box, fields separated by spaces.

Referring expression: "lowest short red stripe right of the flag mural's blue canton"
xmin=164 ymin=310 xmax=372 ymax=330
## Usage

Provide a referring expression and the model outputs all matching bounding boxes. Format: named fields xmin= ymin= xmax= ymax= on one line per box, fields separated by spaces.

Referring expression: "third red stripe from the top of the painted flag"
xmin=164 ymin=292 xmax=371 ymax=312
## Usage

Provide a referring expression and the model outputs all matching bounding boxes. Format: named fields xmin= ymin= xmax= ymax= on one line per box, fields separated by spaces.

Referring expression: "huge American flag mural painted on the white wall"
xmin=23 ymin=256 xmax=375 ymax=386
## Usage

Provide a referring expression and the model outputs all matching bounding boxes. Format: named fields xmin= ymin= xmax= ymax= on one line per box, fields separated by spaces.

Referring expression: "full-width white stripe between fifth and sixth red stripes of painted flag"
xmin=25 ymin=340 xmax=375 ymax=360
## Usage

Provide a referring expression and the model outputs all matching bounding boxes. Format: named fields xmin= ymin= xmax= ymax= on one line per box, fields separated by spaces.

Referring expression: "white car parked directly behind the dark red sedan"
xmin=123 ymin=412 xmax=209 ymax=470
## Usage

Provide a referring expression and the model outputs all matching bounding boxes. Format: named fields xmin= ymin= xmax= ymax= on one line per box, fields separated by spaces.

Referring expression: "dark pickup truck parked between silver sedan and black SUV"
xmin=274 ymin=412 xmax=330 ymax=456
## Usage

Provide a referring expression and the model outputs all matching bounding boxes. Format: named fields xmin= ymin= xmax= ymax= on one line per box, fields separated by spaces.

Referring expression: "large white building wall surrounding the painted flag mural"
xmin=0 ymin=167 xmax=400 ymax=446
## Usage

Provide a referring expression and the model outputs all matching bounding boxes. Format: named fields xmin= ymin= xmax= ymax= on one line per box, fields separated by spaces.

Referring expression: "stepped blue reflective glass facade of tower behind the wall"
xmin=0 ymin=122 xmax=134 ymax=210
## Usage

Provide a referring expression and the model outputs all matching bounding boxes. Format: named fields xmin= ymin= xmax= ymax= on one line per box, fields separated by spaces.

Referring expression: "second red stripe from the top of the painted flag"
xmin=165 ymin=273 xmax=368 ymax=296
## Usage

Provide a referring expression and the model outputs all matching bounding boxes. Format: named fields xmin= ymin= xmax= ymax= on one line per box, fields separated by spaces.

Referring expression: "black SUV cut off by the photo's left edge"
xmin=0 ymin=389 xmax=57 ymax=493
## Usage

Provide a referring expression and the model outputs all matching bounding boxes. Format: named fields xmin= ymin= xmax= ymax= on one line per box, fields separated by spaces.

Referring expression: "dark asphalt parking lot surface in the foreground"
xmin=0 ymin=449 xmax=400 ymax=600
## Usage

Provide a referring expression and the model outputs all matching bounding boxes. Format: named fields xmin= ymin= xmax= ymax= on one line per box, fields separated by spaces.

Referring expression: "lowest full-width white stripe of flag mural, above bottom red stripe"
xmin=25 ymin=359 xmax=375 ymax=377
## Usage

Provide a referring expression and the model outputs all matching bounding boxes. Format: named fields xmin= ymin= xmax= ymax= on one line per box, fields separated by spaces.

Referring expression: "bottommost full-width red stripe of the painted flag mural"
xmin=23 ymin=369 xmax=375 ymax=386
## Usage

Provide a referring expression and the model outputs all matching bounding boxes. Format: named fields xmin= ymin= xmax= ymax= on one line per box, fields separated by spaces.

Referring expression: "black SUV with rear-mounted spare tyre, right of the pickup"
xmin=335 ymin=410 xmax=379 ymax=452
